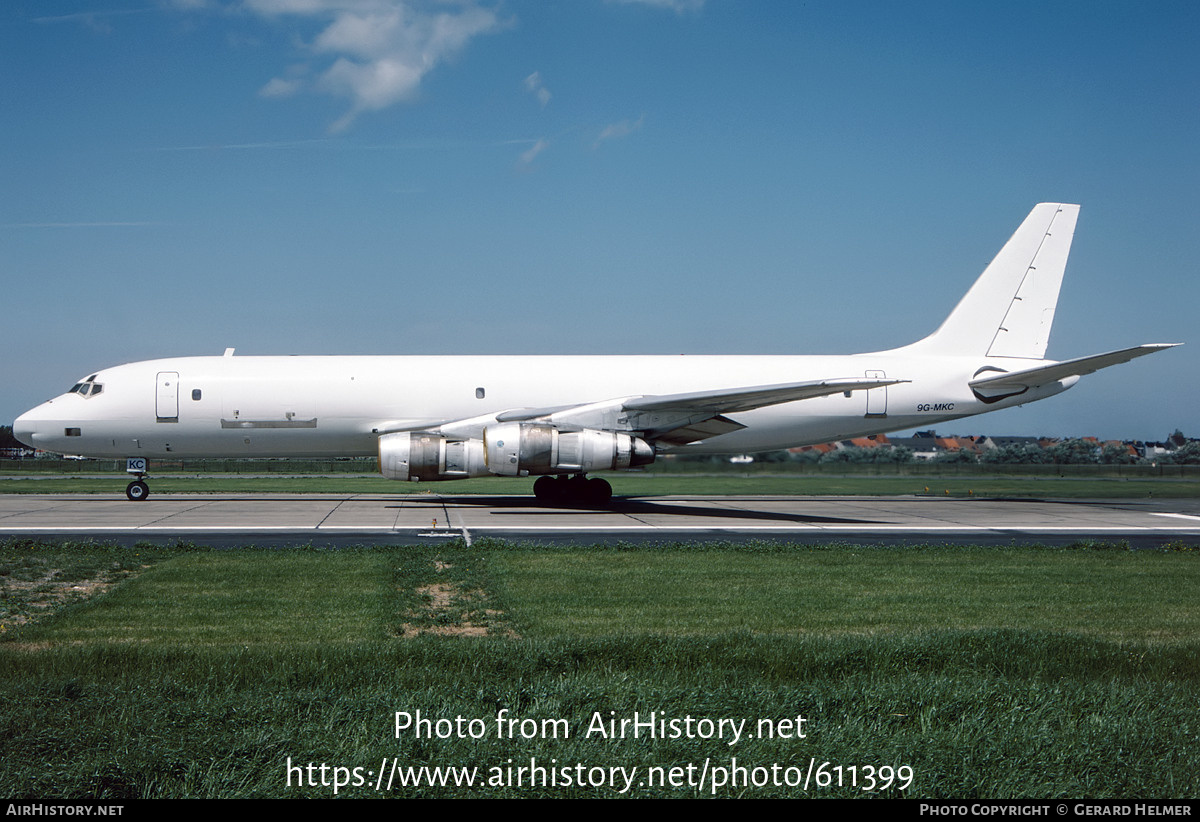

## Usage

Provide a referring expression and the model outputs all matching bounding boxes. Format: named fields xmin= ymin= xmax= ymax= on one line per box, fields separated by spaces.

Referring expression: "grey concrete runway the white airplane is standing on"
xmin=0 ymin=493 xmax=1200 ymax=547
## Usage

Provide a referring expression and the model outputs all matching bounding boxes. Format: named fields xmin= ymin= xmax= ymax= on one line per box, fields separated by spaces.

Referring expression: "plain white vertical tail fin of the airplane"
xmin=913 ymin=203 xmax=1079 ymax=359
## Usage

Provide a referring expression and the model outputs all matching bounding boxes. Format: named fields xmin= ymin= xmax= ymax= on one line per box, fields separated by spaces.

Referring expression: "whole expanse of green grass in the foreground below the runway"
xmin=0 ymin=541 xmax=1200 ymax=802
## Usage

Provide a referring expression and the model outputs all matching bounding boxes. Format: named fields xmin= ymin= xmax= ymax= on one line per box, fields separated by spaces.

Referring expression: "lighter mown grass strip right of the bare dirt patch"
xmin=484 ymin=546 xmax=1200 ymax=642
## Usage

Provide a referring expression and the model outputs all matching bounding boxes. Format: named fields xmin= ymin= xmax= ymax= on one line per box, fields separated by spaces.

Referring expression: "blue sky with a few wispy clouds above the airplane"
xmin=0 ymin=0 xmax=1200 ymax=439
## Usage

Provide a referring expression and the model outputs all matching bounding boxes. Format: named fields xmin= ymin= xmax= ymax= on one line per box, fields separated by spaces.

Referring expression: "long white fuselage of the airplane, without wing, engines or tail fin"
xmin=14 ymin=349 xmax=1075 ymax=458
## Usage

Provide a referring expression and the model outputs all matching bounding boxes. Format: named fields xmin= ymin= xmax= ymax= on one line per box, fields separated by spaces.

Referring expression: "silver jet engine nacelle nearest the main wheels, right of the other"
xmin=484 ymin=422 xmax=654 ymax=476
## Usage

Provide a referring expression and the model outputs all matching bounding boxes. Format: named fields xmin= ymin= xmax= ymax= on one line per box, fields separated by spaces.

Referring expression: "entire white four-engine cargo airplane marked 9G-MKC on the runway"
xmin=13 ymin=203 xmax=1170 ymax=504
